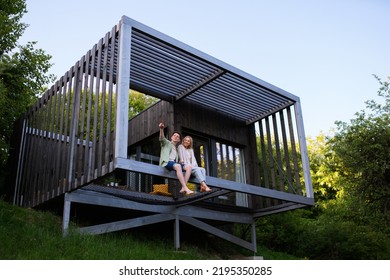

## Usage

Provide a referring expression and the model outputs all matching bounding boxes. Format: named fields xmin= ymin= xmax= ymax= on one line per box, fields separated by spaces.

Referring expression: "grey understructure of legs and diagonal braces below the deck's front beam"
xmin=63 ymin=185 xmax=257 ymax=252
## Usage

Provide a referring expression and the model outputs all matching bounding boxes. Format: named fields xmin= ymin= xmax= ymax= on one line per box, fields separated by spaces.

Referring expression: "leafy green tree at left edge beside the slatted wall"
xmin=0 ymin=0 xmax=54 ymax=190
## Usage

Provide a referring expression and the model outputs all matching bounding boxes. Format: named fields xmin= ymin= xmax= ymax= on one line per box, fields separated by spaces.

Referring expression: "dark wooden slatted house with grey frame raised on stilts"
xmin=14 ymin=16 xmax=314 ymax=252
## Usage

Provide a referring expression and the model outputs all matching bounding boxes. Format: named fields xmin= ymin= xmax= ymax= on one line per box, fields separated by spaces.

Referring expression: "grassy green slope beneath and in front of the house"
xmin=0 ymin=199 xmax=296 ymax=260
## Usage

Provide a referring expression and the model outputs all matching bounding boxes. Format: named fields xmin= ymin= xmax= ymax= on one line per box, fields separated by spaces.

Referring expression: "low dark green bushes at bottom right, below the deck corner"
xmin=257 ymin=206 xmax=390 ymax=260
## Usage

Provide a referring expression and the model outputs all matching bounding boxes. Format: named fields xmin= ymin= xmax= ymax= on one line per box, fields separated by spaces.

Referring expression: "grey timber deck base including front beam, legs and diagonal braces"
xmin=63 ymin=159 xmax=314 ymax=252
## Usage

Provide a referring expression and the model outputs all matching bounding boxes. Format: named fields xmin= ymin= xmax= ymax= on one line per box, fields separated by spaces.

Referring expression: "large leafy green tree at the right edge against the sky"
xmin=328 ymin=76 xmax=390 ymax=228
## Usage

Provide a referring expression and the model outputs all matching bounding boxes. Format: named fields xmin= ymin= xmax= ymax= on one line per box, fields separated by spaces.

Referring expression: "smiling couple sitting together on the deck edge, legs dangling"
xmin=159 ymin=123 xmax=211 ymax=194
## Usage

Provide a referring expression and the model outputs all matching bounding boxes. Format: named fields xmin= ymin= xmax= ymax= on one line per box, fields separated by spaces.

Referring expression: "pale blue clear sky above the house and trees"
xmin=19 ymin=0 xmax=390 ymax=137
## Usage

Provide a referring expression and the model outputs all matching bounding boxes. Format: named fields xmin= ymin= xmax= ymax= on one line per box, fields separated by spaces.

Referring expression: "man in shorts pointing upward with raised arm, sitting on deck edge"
xmin=158 ymin=123 xmax=194 ymax=194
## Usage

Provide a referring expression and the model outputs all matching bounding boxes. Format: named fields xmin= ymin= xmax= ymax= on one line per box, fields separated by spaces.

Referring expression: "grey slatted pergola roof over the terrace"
xmin=122 ymin=16 xmax=299 ymax=124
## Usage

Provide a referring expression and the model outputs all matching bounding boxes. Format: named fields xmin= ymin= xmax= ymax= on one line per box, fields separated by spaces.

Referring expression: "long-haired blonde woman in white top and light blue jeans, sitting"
xmin=178 ymin=136 xmax=211 ymax=192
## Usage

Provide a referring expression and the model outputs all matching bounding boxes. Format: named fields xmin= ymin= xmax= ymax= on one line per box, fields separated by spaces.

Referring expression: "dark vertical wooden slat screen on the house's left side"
xmin=15 ymin=26 xmax=120 ymax=207
